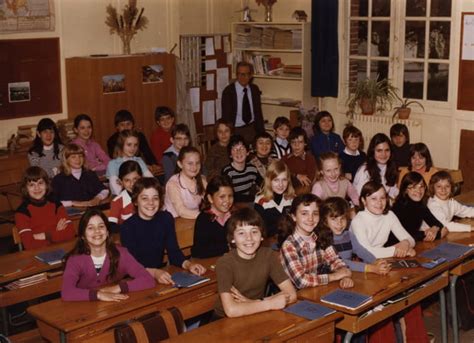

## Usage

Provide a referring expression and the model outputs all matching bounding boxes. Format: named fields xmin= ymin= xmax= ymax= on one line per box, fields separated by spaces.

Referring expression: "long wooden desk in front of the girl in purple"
xmin=28 ymin=258 xmax=217 ymax=342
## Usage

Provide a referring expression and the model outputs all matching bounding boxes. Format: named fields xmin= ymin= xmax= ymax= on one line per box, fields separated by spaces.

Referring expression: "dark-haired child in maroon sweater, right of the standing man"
xmin=283 ymin=126 xmax=317 ymax=194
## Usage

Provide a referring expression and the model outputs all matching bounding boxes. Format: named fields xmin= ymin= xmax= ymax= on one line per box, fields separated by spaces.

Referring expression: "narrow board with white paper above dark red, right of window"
xmin=458 ymin=12 xmax=474 ymax=111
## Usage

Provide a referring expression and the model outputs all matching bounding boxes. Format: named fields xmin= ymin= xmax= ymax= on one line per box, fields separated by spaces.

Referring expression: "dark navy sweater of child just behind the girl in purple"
xmin=120 ymin=211 xmax=185 ymax=268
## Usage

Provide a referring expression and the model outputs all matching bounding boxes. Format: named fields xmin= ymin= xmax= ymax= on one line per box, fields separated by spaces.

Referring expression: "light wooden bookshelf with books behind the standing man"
xmin=232 ymin=22 xmax=311 ymax=123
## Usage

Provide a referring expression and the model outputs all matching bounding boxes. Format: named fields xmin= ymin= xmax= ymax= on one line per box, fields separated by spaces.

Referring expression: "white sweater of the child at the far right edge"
xmin=428 ymin=196 xmax=474 ymax=232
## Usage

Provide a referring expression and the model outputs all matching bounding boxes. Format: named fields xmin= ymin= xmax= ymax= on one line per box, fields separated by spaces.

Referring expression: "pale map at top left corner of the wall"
xmin=0 ymin=0 xmax=54 ymax=34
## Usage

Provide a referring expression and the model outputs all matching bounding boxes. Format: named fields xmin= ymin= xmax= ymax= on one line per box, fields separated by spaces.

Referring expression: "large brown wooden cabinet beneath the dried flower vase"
xmin=66 ymin=53 xmax=176 ymax=149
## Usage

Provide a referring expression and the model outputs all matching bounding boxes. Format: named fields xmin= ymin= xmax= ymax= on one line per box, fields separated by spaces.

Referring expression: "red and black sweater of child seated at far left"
xmin=15 ymin=200 xmax=75 ymax=249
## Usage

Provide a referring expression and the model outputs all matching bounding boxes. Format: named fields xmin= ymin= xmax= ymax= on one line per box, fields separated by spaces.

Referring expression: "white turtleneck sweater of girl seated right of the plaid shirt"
xmin=350 ymin=210 xmax=415 ymax=258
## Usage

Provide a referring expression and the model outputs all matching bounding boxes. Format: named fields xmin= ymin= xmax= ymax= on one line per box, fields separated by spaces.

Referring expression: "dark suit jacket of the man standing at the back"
xmin=222 ymin=82 xmax=264 ymax=132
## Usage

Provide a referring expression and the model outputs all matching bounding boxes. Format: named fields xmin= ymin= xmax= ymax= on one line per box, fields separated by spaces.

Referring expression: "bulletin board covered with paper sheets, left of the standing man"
xmin=180 ymin=34 xmax=232 ymax=135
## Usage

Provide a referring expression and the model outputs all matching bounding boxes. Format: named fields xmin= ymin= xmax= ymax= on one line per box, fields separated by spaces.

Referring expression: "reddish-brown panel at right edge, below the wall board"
xmin=459 ymin=130 xmax=474 ymax=193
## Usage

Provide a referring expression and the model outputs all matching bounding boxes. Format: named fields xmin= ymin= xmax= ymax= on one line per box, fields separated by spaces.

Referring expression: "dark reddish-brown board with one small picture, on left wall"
xmin=0 ymin=38 xmax=62 ymax=120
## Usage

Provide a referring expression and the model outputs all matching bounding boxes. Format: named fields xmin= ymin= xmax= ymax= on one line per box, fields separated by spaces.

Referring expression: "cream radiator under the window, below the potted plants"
xmin=352 ymin=114 xmax=422 ymax=149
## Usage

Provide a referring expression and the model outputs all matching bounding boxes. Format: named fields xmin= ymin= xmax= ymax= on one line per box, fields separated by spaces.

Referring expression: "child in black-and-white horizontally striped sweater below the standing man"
xmin=222 ymin=135 xmax=262 ymax=203
